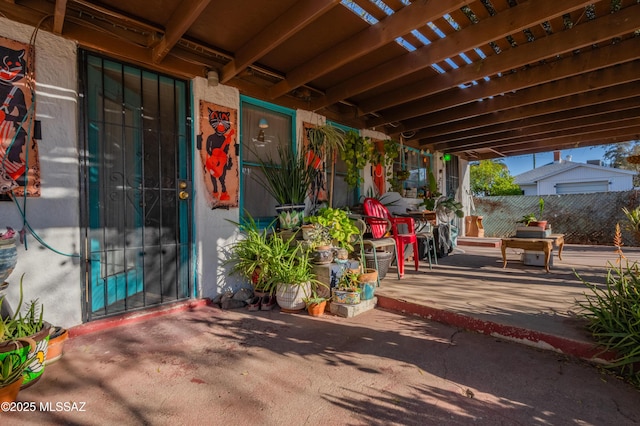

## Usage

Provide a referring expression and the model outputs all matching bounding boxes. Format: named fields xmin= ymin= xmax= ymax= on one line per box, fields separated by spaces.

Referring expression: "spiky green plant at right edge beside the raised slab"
xmin=576 ymin=224 xmax=640 ymax=387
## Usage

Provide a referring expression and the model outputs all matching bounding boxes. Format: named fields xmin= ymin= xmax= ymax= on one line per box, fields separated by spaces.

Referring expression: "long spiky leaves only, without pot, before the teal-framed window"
xmin=254 ymin=145 xmax=318 ymax=206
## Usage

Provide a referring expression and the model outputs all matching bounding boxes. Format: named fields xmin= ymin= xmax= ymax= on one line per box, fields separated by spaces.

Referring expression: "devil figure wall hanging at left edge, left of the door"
xmin=0 ymin=37 xmax=40 ymax=196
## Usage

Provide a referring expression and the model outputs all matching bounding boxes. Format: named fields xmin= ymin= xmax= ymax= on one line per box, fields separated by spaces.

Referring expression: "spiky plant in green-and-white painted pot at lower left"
xmin=0 ymin=274 xmax=51 ymax=389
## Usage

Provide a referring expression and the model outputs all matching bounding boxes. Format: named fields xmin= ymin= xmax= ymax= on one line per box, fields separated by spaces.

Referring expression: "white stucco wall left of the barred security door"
xmin=0 ymin=18 xmax=82 ymax=327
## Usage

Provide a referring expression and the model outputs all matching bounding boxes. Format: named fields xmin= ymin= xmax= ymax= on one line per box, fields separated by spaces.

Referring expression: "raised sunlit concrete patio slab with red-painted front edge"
xmin=377 ymin=238 xmax=640 ymax=359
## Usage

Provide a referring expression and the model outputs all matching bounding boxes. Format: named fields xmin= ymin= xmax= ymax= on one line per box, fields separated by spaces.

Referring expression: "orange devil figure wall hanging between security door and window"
xmin=197 ymin=101 xmax=239 ymax=208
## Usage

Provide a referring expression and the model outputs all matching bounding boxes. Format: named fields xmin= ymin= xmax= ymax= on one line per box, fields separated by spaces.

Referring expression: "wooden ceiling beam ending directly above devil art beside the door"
xmin=220 ymin=0 xmax=340 ymax=84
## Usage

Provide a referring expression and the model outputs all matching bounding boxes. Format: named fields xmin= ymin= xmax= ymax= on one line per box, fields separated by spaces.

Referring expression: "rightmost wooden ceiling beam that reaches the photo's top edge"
xmin=312 ymin=0 xmax=593 ymax=109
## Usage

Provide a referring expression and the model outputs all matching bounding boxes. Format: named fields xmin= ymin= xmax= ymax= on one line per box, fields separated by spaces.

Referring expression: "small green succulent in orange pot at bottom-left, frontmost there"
xmin=0 ymin=338 xmax=36 ymax=403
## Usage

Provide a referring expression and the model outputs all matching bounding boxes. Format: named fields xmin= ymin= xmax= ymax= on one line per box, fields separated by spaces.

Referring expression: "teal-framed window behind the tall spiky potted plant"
xmin=240 ymin=97 xmax=295 ymax=226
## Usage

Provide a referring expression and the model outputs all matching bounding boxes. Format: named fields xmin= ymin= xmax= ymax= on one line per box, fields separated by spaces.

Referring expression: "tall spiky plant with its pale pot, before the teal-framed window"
xmin=254 ymin=145 xmax=318 ymax=229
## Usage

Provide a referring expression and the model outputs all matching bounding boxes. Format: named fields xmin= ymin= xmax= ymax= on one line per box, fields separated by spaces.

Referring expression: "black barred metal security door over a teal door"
xmin=82 ymin=52 xmax=192 ymax=320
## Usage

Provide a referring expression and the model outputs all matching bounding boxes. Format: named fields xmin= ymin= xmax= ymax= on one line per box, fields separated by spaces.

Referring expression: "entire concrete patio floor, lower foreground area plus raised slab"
xmin=5 ymin=240 xmax=640 ymax=425
